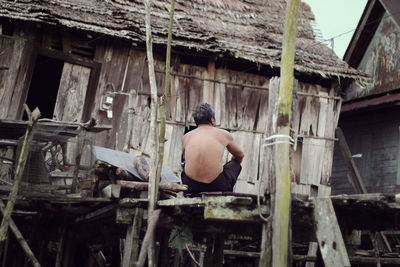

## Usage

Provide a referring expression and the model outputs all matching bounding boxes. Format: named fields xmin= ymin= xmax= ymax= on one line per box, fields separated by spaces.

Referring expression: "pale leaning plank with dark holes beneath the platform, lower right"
xmin=313 ymin=198 xmax=350 ymax=267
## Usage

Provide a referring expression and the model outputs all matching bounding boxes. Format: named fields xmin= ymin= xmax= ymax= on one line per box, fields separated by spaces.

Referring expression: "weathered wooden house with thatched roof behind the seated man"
xmin=0 ymin=0 xmax=366 ymax=197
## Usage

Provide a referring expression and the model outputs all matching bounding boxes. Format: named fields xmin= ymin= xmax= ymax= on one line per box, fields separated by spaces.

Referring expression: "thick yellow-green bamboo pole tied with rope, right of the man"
xmin=272 ymin=0 xmax=300 ymax=267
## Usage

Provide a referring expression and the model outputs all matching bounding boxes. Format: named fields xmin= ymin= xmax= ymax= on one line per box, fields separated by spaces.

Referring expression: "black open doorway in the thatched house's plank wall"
xmin=24 ymin=55 xmax=64 ymax=120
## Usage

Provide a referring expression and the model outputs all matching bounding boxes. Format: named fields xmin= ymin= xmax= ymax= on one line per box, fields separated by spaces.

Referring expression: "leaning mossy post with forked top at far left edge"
xmin=0 ymin=104 xmax=40 ymax=253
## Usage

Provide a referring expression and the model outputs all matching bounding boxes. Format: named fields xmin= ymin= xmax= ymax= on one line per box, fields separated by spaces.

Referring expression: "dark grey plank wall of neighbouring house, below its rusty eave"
xmin=331 ymin=107 xmax=400 ymax=194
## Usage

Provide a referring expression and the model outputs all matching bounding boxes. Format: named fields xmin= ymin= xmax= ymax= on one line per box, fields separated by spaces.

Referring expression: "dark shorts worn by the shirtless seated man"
xmin=181 ymin=160 xmax=242 ymax=194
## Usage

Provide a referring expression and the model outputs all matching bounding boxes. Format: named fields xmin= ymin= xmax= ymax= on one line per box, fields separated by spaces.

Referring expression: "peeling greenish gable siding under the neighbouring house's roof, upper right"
xmin=346 ymin=13 xmax=400 ymax=100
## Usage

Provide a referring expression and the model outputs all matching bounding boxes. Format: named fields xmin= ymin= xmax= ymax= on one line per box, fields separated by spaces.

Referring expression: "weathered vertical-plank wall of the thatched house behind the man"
xmin=0 ymin=22 xmax=340 ymax=194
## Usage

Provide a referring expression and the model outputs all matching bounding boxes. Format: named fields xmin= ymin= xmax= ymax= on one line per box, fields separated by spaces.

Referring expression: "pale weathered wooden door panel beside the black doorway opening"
xmin=53 ymin=62 xmax=91 ymax=122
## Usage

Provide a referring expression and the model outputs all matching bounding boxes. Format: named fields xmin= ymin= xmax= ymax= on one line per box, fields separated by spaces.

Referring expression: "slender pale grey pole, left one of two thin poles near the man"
xmin=142 ymin=0 xmax=159 ymax=267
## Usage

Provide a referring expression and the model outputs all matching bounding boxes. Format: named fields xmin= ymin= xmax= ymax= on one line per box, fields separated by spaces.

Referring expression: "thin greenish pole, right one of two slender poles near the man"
xmin=157 ymin=0 xmax=175 ymax=199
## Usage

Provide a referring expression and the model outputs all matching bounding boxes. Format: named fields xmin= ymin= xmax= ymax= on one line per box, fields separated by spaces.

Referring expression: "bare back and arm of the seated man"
xmin=182 ymin=124 xmax=243 ymax=183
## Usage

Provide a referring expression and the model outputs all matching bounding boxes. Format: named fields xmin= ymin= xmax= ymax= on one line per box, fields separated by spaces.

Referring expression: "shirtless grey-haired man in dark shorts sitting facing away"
xmin=181 ymin=103 xmax=244 ymax=193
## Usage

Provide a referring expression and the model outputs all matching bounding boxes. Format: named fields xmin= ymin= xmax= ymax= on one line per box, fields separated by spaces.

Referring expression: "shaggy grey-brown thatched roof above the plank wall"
xmin=0 ymin=0 xmax=363 ymax=78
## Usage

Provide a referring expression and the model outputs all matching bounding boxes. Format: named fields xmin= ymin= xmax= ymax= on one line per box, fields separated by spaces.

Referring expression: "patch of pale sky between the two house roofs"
xmin=302 ymin=0 xmax=367 ymax=58
